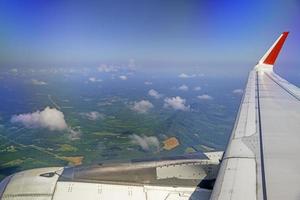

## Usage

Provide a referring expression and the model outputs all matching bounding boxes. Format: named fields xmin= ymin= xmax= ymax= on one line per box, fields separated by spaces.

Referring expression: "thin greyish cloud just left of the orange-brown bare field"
xmin=129 ymin=134 xmax=159 ymax=151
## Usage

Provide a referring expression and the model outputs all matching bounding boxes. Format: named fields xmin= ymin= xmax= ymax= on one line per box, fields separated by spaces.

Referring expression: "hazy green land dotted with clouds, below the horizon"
xmin=0 ymin=63 xmax=244 ymax=180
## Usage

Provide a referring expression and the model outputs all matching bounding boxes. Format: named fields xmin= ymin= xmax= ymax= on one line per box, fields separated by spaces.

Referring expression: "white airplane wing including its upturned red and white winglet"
xmin=210 ymin=32 xmax=300 ymax=200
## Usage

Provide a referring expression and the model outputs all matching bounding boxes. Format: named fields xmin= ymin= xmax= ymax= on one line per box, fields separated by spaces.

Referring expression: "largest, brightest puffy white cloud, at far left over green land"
xmin=11 ymin=107 xmax=68 ymax=131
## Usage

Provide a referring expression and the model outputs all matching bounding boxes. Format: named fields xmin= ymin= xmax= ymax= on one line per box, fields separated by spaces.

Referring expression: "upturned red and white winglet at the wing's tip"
xmin=259 ymin=32 xmax=289 ymax=67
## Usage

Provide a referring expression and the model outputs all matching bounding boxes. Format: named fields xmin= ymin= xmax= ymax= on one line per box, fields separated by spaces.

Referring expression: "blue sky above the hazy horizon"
xmin=0 ymin=0 xmax=300 ymax=71
